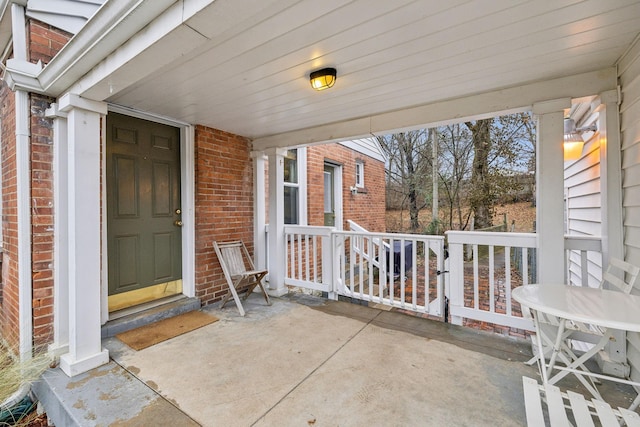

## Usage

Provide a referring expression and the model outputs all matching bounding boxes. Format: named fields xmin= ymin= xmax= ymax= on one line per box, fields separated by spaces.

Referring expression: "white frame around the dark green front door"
xmin=101 ymin=105 xmax=196 ymax=324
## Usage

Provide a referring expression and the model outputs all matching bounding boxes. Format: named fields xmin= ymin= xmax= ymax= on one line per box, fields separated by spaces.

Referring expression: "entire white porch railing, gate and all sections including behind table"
xmin=278 ymin=227 xmax=602 ymax=331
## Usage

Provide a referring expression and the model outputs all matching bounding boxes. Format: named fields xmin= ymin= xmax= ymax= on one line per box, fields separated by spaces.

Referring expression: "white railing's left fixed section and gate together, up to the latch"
xmin=284 ymin=225 xmax=445 ymax=317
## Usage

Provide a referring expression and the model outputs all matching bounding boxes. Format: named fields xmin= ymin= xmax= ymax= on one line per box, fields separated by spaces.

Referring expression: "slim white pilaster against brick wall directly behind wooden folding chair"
xmin=251 ymin=151 xmax=267 ymax=270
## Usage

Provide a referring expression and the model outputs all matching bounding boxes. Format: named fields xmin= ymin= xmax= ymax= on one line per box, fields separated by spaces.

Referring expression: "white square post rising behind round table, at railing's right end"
xmin=533 ymin=98 xmax=571 ymax=283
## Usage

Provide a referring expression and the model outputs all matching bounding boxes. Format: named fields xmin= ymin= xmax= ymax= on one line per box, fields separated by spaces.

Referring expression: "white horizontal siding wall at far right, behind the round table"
xmin=618 ymin=36 xmax=640 ymax=381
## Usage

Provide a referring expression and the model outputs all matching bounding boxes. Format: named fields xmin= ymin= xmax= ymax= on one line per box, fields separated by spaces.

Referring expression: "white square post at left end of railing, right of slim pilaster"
xmin=266 ymin=148 xmax=287 ymax=296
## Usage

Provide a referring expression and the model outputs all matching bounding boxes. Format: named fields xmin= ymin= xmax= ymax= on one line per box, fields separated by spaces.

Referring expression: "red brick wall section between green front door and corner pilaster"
xmin=195 ymin=126 xmax=253 ymax=305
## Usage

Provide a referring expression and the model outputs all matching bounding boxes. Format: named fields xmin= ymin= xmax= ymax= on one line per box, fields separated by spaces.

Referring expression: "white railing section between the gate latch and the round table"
xmin=445 ymin=231 xmax=537 ymax=330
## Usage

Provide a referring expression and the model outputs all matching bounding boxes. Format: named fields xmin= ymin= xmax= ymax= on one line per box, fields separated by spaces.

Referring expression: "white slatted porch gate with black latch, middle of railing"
xmin=332 ymin=231 xmax=445 ymax=317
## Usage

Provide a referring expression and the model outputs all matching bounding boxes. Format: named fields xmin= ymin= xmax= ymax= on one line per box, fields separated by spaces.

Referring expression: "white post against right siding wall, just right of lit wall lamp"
xmin=592 ymin=90 xmax=628 ymax=376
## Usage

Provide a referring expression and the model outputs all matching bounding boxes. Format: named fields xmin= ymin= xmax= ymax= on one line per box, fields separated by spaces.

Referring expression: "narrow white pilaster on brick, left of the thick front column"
xmin=46 ymin=104 xmax=69 ymax=356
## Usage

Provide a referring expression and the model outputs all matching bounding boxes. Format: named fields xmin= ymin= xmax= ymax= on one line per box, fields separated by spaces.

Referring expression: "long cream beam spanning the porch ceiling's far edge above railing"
xmin=253 ymin=67 xmax=617 ymax=151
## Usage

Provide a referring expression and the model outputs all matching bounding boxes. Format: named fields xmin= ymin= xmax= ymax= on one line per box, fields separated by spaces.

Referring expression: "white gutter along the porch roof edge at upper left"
xmin=0 ymin=0 xmax=183 ymax=98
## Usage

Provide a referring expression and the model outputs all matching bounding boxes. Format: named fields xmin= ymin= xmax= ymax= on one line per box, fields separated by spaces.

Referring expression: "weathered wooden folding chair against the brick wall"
xmin=213 ymin=240 xmax=271 ymax=316
